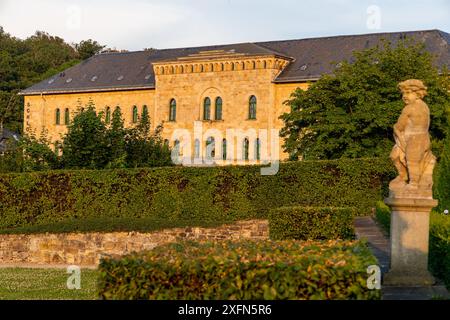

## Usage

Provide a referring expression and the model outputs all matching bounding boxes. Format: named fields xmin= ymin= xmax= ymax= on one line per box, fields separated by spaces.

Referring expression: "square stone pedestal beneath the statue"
xmin=383 ymin=198 xmax=438 ymax=286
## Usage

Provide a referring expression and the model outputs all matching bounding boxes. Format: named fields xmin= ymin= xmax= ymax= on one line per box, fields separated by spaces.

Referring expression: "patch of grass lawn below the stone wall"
xmin=0 ymin=268 xmax=97 ymax=300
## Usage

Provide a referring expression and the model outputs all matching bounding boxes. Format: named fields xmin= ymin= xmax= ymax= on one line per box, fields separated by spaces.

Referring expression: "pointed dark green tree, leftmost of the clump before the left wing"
xmin=62 ymin=102 xmax=111 ymax=169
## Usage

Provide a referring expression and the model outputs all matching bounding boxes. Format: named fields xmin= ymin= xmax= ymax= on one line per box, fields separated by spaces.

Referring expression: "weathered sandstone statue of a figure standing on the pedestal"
xmin=389 ymin=79 xmax=436 ymax=199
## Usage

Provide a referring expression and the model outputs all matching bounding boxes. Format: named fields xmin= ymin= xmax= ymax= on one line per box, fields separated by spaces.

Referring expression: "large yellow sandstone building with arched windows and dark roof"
xmin=20 ymin=30 xmax=450 ymax=163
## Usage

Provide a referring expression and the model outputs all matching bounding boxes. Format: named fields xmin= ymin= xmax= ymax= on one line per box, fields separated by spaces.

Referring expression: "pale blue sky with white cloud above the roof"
xmin=0 ymin=0 xmax=450 ymax=51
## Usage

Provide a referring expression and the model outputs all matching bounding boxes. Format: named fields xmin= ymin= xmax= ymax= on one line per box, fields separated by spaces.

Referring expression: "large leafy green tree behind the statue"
xmin=281 ymin=41 xmax=450 ymax=159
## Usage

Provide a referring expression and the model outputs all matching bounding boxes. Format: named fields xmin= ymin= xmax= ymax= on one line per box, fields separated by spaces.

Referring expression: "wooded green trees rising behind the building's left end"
xmin=0 ymin=26 xmax=104 ymax=133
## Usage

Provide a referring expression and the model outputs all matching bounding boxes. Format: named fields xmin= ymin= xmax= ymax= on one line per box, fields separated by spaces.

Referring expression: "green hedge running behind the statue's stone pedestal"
xmin=376 ymin=201 xmax=450 ymax=290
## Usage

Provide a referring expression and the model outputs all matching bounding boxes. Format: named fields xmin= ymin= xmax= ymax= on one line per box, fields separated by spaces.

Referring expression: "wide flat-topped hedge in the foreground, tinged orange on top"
xmin=99 ymin=240 xmax=380 ymax=300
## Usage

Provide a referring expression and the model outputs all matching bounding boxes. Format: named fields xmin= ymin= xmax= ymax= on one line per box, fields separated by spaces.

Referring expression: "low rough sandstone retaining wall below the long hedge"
xmin=0 ymin=220 xmax=269 ymax=267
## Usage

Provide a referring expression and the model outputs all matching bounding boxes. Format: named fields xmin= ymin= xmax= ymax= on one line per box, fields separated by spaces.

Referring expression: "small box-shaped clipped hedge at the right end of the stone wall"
xmin=269 ymin=207 xmax=356 ymax=240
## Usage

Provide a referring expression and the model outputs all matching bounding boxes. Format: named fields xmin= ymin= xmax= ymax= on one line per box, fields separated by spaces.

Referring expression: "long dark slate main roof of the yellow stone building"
xmin=20 ymin=30 xmax=450 ymax=95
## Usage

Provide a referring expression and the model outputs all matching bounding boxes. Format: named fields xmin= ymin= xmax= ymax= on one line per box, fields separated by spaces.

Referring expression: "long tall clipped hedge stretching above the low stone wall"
xmin=0 ymin=159 xmax=395 ymax=229
